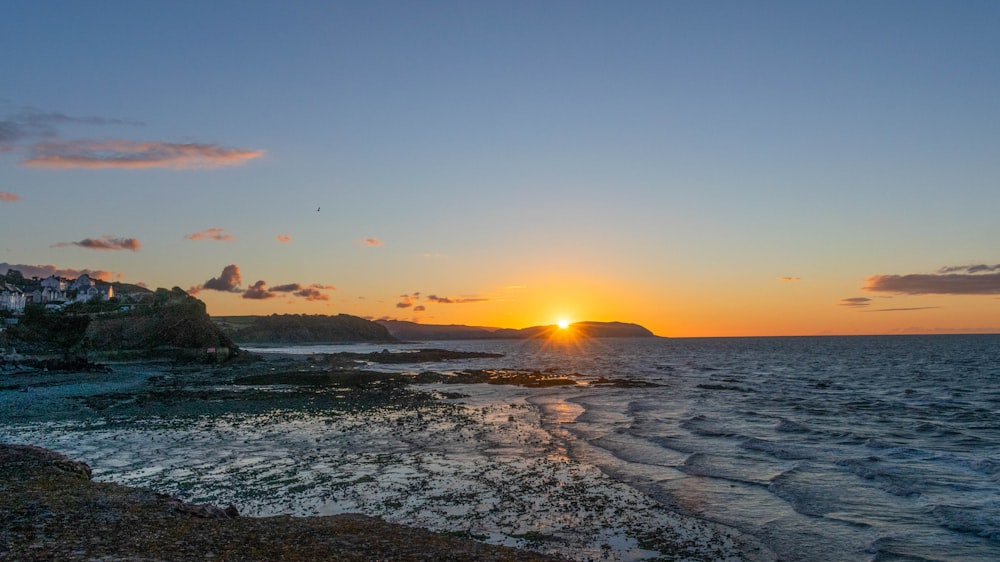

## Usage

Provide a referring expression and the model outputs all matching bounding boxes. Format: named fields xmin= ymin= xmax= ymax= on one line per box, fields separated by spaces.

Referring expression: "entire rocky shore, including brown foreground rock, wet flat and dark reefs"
xmin=0 ymin=350 xmax=766 ymax=561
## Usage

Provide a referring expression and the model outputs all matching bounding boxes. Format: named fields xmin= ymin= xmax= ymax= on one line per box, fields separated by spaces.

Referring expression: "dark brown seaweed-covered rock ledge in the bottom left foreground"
xmin=0 ymin=445 xmax=557 ymax=561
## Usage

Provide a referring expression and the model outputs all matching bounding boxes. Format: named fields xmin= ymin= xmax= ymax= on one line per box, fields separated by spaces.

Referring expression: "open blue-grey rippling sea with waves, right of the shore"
xmin=270 ymin=335 xmax=1000 ymax=562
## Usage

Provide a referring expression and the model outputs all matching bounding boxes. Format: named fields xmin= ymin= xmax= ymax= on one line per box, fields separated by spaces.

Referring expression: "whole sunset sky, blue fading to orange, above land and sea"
xmin=0 ymin=0 xmax=1000 ymax=337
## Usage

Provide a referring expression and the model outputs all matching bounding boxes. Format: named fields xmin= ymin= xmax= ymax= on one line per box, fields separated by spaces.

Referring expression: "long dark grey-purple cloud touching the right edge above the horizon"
xmin=862 ymin=265 xmax=1000 ymax=295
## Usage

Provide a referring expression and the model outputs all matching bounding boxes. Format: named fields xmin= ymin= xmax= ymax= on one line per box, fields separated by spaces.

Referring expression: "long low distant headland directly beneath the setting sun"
xmin=376 ymin=320 xmax=656 ymax=340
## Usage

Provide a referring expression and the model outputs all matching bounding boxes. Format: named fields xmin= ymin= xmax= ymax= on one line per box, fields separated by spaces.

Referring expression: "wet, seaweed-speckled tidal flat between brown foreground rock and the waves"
xmin=0 ymin=356 xmax=769 ymax=560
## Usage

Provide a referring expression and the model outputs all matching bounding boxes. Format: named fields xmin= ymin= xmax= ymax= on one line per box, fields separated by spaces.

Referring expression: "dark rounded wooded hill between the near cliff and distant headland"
xmin=212 ymin=314 xmax=396 ymax=344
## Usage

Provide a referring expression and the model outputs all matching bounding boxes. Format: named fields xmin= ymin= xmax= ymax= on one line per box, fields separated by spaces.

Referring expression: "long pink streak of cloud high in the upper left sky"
xmin=22 ymin=140 xmax=264 ymax=169
